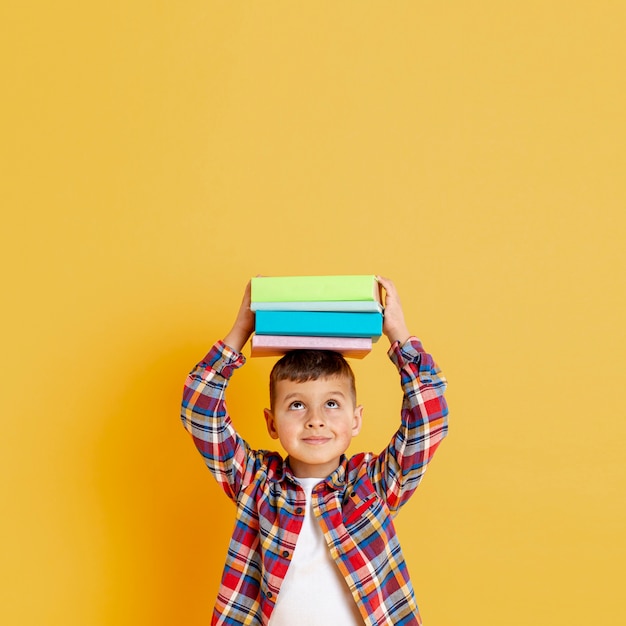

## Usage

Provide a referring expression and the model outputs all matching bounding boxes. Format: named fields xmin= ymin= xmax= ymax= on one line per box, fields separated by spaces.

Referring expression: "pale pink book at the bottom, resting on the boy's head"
xmin=251 ymin=335 xmax=372 ymax=359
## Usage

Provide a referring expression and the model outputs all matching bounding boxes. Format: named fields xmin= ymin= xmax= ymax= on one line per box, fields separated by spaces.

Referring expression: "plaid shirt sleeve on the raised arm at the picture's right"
xmin=371 ymin=337 xmax=448 ymax=514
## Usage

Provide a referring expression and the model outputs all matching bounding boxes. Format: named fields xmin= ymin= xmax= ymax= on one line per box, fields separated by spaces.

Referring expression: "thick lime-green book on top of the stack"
xmin=252 ymin=274 xmax=381 ymax=310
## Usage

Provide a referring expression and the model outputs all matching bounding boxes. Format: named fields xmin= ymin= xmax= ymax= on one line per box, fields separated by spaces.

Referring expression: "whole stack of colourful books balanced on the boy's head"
xmin=250 ymin=275 xmax=383 ymax=358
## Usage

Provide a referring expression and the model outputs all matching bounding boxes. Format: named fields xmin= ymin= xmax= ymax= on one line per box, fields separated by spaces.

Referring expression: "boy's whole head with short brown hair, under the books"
xmin=265 ymin=350 xmax=363 ymax=478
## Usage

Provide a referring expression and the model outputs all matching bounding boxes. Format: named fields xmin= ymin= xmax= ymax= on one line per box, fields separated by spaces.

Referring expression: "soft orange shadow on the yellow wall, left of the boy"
xmin=93 ymin=334 xmax=234 ymax=626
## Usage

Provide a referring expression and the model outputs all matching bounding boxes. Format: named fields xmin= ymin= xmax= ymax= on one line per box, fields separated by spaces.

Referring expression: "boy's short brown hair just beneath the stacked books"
xmin=270 ymin=350 xmax=356 ymax=409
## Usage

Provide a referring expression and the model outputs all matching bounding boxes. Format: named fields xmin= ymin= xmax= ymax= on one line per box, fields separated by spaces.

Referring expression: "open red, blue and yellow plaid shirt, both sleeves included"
xmin=182 ymin=338 xmax=448 ymax=626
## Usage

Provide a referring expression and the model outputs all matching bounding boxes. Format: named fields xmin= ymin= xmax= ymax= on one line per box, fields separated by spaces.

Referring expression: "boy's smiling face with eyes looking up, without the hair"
xmin=265 ymin=376 xmax=363 ymax=478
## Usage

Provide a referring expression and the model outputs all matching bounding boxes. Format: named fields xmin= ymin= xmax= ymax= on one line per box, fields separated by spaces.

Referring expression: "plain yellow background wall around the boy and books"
xmin=0 ymin=0 xmax=626 ymax=626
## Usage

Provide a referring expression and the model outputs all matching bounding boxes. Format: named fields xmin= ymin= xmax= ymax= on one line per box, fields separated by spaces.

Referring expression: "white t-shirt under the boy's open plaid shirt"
xmin=270 ymin=478 xmax=364 ymax=626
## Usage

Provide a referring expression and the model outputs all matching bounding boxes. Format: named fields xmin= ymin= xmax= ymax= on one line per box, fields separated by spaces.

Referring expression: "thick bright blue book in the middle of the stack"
xmin=255 ymin=311 xmax=383 ymax=337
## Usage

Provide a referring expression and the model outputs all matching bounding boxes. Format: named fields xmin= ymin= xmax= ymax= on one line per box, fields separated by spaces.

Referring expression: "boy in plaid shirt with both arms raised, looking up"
xmin=182 ymin=277 xmax=448 ymax=626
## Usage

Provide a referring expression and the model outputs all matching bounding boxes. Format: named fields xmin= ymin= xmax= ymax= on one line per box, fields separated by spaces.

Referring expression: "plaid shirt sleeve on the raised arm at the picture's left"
xmin=181 ymin=341 xmax=254 ymax=500
